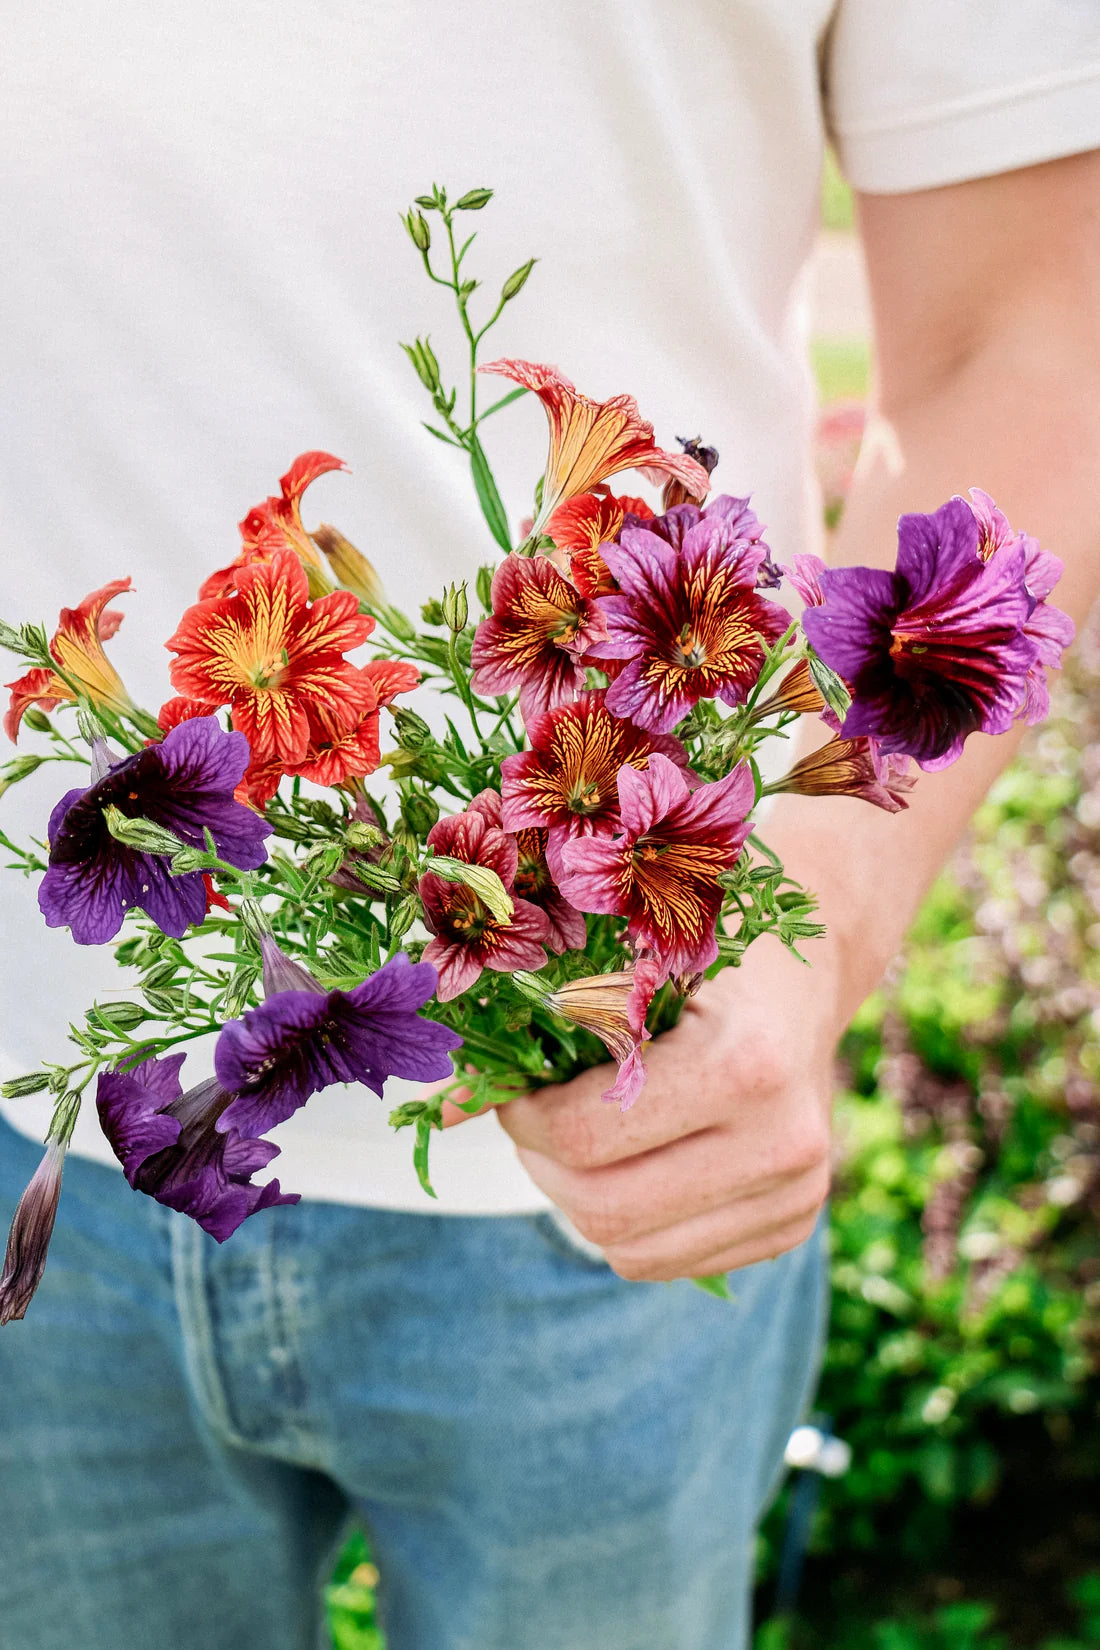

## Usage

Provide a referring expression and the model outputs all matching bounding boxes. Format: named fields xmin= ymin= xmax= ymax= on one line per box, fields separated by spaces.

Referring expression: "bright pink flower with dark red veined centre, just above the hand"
xmin=561 ymin=752 xmax=755 ymax=978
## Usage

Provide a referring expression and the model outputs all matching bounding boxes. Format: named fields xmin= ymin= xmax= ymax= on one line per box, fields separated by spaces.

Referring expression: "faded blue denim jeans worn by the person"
xmin=0 ymin=1122 xmax=823 ymax=1650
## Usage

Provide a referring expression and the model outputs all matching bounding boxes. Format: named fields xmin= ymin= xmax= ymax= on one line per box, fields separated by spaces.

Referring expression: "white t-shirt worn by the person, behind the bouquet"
xmin=0 ymin=0 xmax=1100 ymax=1213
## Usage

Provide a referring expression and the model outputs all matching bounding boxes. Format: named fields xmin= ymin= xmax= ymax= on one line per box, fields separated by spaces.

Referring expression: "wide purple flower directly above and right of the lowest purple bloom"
xmin=214 ymin=936 xmax=462 ymax=1134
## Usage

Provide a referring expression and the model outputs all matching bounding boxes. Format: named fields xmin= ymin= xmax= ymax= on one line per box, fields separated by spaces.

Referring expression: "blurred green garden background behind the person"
xmin=328 ymin=158 xmax=1100 ymax=1650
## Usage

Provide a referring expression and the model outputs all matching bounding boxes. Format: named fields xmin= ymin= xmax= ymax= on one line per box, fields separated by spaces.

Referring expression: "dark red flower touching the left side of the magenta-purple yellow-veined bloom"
xmin=472 ymin=554 xmax=607 ymax=721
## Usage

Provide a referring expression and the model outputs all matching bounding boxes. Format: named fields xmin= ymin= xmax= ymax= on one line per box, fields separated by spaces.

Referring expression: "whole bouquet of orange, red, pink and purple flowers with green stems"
xmin=0 ymin=188 xmax=1072 ymax=1322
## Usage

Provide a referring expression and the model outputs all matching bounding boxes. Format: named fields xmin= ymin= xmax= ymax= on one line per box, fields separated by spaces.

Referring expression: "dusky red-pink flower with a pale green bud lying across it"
xmin=421 ymin=805 xmax=549 ymax=1003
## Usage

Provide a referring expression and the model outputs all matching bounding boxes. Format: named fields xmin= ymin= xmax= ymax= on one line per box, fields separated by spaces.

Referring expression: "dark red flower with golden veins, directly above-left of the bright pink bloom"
xmin=501 ymin=690 xmax=688 ymax=878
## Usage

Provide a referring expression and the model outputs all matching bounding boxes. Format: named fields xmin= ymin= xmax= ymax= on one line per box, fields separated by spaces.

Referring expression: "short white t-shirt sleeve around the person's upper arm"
xmin=823 ymin=0 xmax=1100 ymax=195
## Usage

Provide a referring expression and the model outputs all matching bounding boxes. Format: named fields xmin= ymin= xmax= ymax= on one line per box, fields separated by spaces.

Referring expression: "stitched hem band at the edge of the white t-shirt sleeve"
xmin=834 ymin=63 xmax=1100 ymax=195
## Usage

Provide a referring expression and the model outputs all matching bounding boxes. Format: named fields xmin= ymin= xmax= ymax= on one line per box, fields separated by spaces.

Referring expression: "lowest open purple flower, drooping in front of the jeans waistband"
xmin=96 ymin=1054 xmax=299 ymax=1242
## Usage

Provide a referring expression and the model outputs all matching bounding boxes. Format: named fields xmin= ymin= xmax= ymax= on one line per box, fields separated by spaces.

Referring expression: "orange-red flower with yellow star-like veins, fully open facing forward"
xmin=167 ymin=549 xmax=374 ymax=769
